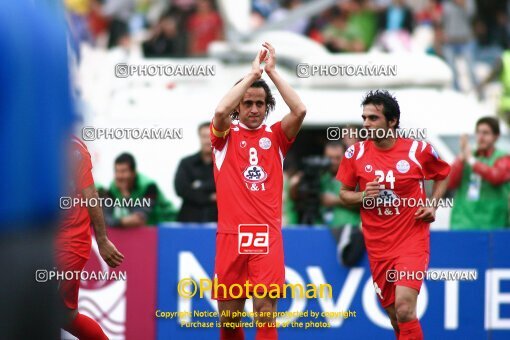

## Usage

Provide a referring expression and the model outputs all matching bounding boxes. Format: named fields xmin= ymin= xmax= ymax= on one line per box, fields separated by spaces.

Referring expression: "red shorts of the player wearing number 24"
xmin=369 ymin=253 xmax=429 ymax=308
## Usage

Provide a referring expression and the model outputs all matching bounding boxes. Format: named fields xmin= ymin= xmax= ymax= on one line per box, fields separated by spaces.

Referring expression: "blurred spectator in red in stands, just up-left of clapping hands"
xmin=187 ymin=0 xmax=223 ymax=56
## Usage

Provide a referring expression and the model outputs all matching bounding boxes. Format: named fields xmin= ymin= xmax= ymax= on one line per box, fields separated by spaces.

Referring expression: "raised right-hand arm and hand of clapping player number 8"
xmin=262 ymin=42 xmax=306 ymax=139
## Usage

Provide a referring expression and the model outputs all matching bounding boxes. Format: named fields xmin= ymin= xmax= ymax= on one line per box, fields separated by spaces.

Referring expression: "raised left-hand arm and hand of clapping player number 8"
xmin=213 ymin=50 xmax=267 ymax=132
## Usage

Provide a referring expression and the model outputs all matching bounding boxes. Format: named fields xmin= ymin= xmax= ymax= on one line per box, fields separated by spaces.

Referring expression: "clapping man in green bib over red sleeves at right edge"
xmin=448 ymin=117 xmax=510 ymax=230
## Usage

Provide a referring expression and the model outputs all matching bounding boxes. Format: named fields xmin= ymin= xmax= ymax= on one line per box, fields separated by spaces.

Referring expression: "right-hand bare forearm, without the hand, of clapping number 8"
xmin=266 ymin=70 xmax=306 ymax=139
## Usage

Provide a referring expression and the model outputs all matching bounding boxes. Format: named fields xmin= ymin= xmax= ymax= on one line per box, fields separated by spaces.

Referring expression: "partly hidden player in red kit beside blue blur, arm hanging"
xmin=55 ymin=136 xmax=124 ymax=339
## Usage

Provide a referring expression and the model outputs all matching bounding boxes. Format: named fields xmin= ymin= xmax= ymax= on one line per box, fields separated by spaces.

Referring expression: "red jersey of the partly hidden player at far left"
xmin=56 ymin=137 xmax=94 ymax=259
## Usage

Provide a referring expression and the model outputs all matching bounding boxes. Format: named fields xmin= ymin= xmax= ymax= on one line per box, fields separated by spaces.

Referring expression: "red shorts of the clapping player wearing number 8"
xmin=212 ymin=232 xmax=285 ymax=300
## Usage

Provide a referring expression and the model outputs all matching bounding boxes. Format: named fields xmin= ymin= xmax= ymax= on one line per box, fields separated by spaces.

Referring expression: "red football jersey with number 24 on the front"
xmin=336 ymin=138 xmax=450 ymax=260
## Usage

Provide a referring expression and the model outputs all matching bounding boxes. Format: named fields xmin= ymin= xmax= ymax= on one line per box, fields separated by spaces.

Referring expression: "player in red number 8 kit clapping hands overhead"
xmin=211 ymin=42 xmax=306 ymax=339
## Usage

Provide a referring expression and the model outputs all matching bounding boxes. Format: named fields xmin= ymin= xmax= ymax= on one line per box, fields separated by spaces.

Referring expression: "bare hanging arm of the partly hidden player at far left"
xmin=82 ymin=184 xmax=124 ymax=268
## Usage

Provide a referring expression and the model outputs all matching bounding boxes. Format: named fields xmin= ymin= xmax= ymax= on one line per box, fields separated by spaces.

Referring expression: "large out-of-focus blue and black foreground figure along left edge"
xmin=0 ymin=0 xmax=75 ymax=340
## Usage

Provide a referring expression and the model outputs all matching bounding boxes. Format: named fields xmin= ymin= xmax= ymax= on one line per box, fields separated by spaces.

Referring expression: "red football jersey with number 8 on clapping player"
xmin=210 ymin=122 xmax=295 ymax=234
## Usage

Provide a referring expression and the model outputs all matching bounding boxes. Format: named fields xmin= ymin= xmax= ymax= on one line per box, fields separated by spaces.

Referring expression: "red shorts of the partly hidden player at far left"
xmin=57 ymin=252 xmax=88 ymax=309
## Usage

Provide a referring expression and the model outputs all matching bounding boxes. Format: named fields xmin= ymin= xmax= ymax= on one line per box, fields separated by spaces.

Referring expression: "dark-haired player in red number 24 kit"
xmin=337 ymin=90 xmax=450 ymax=340
